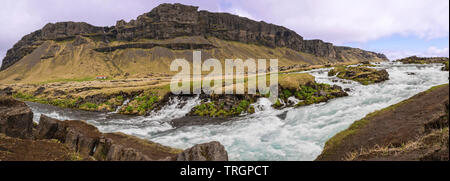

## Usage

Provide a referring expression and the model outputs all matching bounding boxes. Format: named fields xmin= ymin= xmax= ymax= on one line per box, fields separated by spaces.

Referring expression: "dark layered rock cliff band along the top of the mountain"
xmin=0 ymin=4 xmax=387 ymax=70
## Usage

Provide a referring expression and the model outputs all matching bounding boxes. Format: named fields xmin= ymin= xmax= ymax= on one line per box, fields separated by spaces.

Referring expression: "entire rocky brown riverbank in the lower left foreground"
xmin=0 ymin=97 xmax=228 ymax=161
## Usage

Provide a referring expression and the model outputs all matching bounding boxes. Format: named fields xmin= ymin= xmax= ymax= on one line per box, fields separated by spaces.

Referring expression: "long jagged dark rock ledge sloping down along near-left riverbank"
xmin=35 ymin=115 xmax=187 ymax=161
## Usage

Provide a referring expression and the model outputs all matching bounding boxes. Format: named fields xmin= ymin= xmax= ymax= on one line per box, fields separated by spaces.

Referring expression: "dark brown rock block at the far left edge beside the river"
xmin=0 ymin=97 xmax=33 ymax=138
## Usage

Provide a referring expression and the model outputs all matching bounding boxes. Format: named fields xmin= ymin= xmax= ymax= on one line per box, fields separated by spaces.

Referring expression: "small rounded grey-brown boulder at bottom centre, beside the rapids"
xmin=176 ymin=141 xmax=228 ymax=161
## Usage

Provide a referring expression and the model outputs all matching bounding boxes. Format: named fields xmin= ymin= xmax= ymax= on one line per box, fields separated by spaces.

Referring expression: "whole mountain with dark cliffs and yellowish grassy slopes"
xmin=0 ymin=4 xmax=387 ymax=83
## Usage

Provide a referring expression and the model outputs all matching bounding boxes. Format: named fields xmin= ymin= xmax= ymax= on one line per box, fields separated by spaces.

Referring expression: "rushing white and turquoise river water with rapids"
xmin=28 ymin=63 xmax=449 ymax=160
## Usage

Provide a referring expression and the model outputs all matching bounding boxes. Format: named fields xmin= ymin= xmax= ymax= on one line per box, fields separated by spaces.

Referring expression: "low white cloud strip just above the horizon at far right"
xmin=383 ymin=46 xmax=449 ymax=60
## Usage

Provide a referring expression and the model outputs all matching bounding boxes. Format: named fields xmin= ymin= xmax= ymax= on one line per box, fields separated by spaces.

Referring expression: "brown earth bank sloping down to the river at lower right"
xmin=316 ymin=84 xmax=449 ymax=161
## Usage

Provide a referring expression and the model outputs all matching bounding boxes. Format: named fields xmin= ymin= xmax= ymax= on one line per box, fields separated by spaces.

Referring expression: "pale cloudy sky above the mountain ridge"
xmin=0 ymin=0 xmax=449 ymax=64
